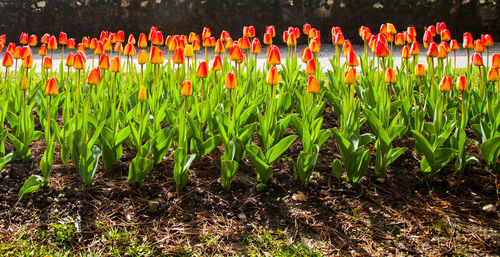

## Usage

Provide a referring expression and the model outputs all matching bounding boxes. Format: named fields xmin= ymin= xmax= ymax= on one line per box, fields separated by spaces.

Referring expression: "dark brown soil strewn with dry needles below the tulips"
xmin=0 ymin=105 xmax=500 ymax=256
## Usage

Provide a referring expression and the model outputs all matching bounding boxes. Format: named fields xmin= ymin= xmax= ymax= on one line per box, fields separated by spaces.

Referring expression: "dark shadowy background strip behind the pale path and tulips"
xmin=0 ymin=0 xmax=500 ymax=43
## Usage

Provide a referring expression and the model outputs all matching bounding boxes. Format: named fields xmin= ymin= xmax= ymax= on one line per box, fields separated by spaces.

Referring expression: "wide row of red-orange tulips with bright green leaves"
xmin=0 ymin=23 xmax=500 ymax=199
